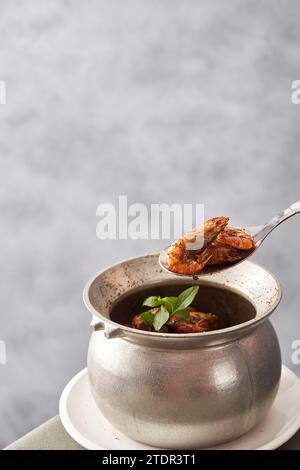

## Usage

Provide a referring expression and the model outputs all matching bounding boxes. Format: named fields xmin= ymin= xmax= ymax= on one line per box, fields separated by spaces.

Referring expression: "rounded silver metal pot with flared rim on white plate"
xmin=84 ymin=254 xmax=281 ymax=449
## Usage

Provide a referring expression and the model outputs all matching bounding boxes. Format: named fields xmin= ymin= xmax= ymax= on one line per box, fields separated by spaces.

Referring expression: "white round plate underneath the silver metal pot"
xmin=59 ymin=366 xmax=300 ymax=450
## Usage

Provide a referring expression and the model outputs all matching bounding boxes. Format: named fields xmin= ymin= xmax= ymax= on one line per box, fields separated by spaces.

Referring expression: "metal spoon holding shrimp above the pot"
xmin=159 ymin=201 xmax=300 ymax=279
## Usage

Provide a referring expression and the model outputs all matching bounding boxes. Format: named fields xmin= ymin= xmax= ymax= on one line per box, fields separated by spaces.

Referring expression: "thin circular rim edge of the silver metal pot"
xmin=83 ymin=252 xmax=282 ymax=340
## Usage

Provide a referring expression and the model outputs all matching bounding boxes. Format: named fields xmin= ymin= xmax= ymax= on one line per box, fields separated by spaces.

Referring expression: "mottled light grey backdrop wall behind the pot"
xmin=0 ymin=0 xmax=300 ymax=446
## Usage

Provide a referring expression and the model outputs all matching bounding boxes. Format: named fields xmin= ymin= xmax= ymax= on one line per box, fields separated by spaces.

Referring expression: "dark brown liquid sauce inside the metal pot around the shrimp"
xmin=110 ymin=280 xmax=256 ymax=328
